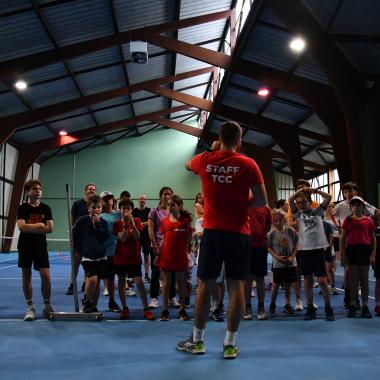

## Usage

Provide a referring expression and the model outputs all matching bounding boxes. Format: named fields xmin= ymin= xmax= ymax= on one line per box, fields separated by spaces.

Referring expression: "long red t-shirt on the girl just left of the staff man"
xmin=160 ymin=216 xmax=192 ymax=272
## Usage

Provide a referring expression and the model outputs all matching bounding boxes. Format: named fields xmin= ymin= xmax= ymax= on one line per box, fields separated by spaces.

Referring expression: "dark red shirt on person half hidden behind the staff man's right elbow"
xmin=248 ymin=207 xmax=272 ymax=247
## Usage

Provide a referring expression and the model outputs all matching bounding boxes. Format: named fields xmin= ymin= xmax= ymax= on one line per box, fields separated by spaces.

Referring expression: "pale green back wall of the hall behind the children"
xmin=40 ymin=130 xmax=201 ymax=250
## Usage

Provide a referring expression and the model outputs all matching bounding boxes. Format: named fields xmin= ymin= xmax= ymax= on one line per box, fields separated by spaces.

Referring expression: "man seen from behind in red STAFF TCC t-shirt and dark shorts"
xmin=177 ymin=121 xmax=267 ymax=359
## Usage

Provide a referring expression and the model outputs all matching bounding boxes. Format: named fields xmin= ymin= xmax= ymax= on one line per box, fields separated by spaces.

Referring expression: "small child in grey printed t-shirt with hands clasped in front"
xmin=268 ymin=209 xmax=298 ymax=314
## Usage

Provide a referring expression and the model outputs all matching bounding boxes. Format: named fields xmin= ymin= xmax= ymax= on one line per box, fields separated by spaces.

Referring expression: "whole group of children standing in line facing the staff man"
xmin=17 ymin=180 xmax=380 ymax=321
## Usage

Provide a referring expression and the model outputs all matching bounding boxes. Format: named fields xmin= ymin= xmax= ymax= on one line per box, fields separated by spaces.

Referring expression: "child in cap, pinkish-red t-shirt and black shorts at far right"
xmin=341 ymin=196 xmax=376 ymax=318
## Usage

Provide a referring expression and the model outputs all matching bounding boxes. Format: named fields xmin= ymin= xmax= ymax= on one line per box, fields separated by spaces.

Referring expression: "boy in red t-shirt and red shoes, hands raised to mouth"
xmin=113 ymin=198 xmax=155 ymax=321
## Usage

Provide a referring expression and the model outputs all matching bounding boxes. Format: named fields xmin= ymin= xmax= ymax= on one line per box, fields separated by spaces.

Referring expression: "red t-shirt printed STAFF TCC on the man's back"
xmin=191 ymin=150 xmax=263 ymax=235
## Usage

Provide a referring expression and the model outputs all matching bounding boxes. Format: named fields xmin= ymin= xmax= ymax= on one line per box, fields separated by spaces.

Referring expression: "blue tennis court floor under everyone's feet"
xmin=0 ymin=253 xmax=380 ymax=380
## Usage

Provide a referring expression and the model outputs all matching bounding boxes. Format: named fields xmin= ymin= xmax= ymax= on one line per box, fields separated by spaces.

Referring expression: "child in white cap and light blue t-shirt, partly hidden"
xmin=100 ymin=191 xmax=121 ymax=313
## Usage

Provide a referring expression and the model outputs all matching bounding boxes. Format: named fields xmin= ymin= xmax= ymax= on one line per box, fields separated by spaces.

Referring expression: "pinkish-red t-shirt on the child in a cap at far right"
xmin=342 ymin=216 xmax=376 ymax=245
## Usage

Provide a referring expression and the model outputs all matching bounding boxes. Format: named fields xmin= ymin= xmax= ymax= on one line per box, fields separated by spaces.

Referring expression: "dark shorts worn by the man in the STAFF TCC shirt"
xmin=197 ymin=229 xmax=251 ymax=280
